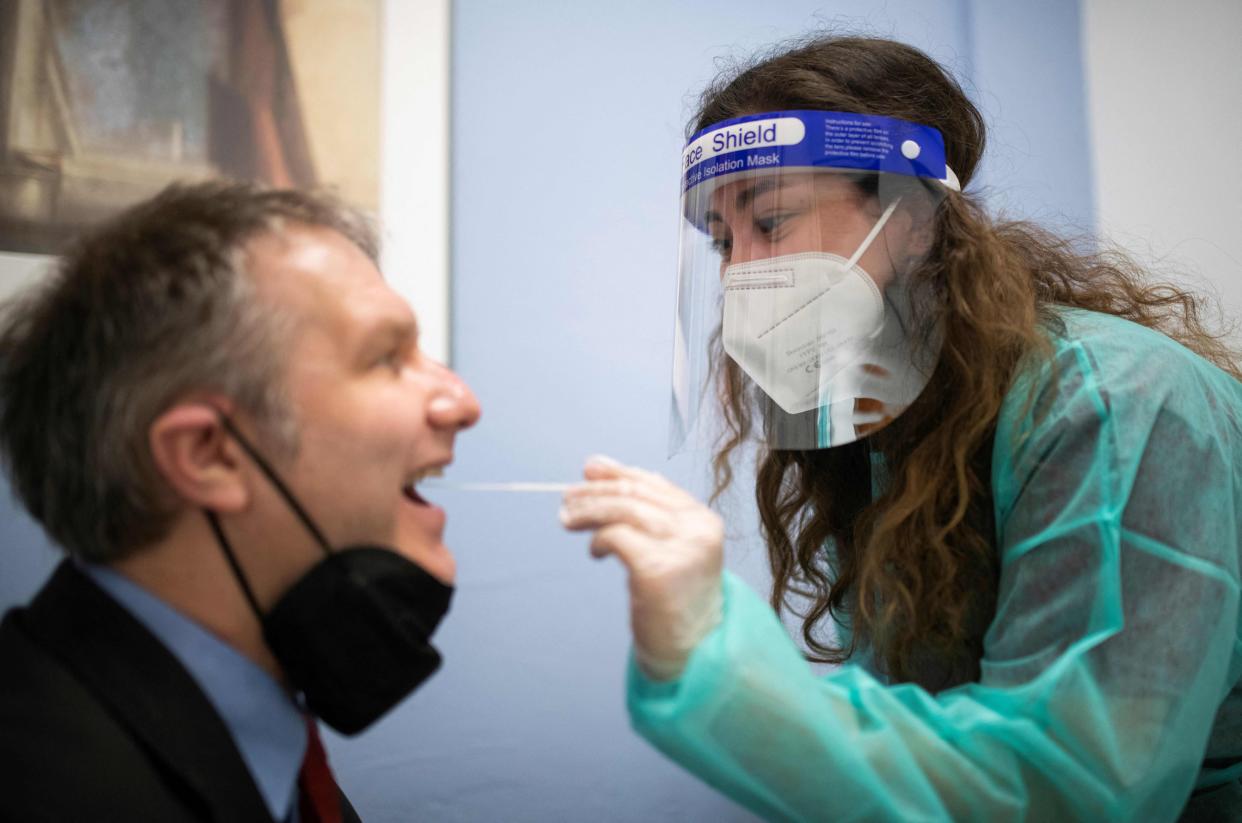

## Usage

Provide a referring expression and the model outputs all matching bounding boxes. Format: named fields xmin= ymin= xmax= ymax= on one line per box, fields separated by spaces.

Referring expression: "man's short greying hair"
xmin=0 ymin=182 xmax=379 ymax=562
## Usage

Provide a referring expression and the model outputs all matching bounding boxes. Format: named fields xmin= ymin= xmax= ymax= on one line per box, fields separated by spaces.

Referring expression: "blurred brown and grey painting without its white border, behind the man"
xmin=0 ymin=0 xmax=380 ymax=254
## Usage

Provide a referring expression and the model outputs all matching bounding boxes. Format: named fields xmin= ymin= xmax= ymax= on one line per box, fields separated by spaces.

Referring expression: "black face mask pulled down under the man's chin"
xmin=205 ymin=415 xmax=453 ymax=735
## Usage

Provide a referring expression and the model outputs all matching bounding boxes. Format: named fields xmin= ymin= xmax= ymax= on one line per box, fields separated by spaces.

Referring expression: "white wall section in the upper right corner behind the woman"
xmin=1083 ymin=0 xmax=1242 ymax=343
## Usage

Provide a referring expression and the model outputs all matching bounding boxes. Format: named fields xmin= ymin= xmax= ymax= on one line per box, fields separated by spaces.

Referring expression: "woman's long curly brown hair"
xmin=691 ymin=36 xmax=1242 ymax=691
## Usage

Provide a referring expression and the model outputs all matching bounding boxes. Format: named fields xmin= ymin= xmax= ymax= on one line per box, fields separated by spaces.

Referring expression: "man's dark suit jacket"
xmin=0 ymin=562 xmax=358 ymax=823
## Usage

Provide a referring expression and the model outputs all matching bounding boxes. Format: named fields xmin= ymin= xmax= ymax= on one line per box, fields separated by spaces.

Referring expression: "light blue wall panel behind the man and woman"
xmin=0 ymin=0 xmax=1092 ymax=822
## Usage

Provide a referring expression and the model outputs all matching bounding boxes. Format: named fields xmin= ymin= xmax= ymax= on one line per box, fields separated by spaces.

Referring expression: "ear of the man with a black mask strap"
xmin=148 ymin=402 xmax=250 ymax=511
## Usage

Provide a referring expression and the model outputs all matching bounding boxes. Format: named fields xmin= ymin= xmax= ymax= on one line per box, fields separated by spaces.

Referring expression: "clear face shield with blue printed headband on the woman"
xmin=669 ymin=110 xmax=958 ymax=453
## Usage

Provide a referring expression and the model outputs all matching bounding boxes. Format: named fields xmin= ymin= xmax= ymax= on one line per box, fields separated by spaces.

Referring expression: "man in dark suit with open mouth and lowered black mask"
xmin=0 ymin=182 xmax=479 ymax=823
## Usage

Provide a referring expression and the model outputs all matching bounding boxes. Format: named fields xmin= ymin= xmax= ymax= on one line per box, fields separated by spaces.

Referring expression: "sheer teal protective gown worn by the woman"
xmin=628 ymin=309 xmax=1242 ymax=821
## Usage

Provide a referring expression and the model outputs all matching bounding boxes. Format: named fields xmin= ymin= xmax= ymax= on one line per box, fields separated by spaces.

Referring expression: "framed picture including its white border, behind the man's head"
xmin=0 ymin=0 xmax=448 ymax=358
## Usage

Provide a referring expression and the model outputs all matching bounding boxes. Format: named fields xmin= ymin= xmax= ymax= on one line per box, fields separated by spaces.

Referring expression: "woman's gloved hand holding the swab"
xmin=560 ymin=457 xmax=724 ymax=680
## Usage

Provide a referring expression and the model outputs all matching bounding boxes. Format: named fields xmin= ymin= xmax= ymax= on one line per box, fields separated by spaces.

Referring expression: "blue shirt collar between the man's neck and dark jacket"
xmin=79 ymin=562 xmax=307 ymax=821
